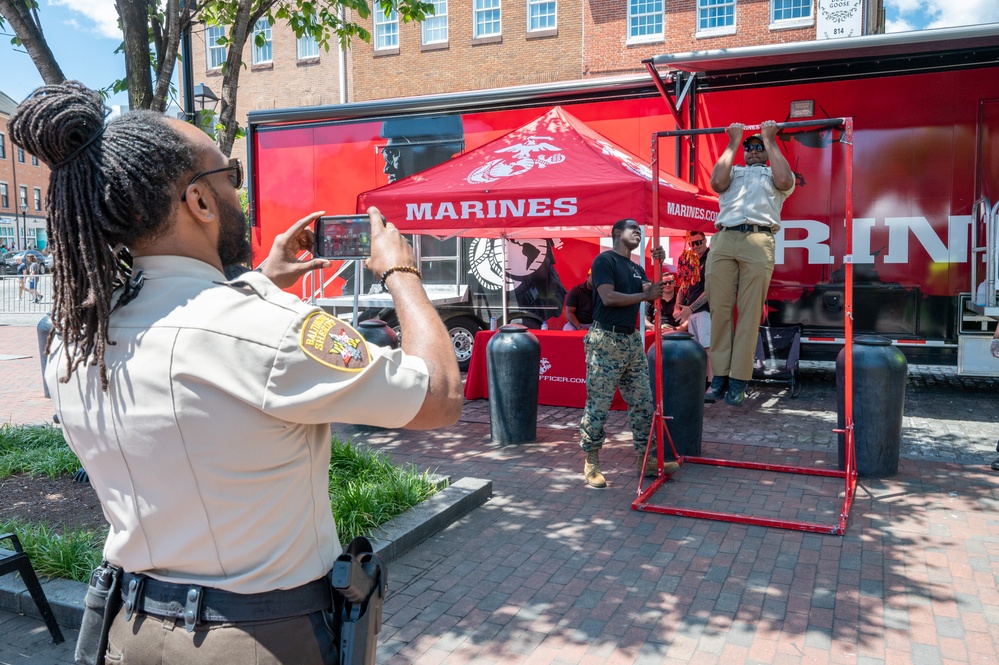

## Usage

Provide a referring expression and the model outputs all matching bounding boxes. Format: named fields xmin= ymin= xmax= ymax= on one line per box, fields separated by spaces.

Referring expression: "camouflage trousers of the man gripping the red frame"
xmin=579 ymin=328 xmax=653 ymax=452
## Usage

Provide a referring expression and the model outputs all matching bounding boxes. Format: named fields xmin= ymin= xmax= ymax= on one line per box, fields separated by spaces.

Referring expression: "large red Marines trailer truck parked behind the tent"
xmin=248 ymin=24 xmax=999 ymax=375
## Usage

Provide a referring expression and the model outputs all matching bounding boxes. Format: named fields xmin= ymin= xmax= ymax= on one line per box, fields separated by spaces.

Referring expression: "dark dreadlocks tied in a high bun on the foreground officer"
xmin=8 ymin=81 xmax=198 ymax=389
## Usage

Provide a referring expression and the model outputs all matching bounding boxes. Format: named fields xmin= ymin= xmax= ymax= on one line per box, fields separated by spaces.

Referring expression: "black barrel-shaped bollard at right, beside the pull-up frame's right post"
xmin=836 ymin=335 xmax=909 ymax=478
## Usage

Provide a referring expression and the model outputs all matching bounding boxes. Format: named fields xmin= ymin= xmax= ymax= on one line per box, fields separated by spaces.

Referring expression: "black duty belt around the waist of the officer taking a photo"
xmin=121 ymin=573 xmax=333 ymax=631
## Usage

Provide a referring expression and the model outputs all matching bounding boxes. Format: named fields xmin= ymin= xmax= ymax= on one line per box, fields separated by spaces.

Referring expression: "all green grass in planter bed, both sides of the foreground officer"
xmin=0 ymin=434 xmax=439 ymax=582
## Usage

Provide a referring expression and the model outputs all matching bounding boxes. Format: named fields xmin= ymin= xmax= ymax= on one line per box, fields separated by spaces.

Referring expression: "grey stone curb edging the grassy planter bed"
xmin=0 ymin=478 xmax=493 ymax=630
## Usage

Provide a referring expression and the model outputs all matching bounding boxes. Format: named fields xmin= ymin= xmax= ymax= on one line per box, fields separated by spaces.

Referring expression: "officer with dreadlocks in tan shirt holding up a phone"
xmin=9 ymin=82 xmax=462 ymax=664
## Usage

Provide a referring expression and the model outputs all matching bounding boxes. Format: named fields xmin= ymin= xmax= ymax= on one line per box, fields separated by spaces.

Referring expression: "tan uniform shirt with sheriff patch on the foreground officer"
xmin=45 ymin=256 xmax=428 ymax=593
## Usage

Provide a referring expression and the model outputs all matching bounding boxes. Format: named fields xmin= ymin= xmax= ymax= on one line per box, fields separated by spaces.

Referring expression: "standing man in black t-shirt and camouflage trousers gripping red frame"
xmin=579 ymin=219 xmax=677 ymax=488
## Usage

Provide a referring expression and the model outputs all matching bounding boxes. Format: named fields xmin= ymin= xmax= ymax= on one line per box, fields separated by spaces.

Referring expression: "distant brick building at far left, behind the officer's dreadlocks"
xmin=0 ymin=91 xmax=49 ymax=249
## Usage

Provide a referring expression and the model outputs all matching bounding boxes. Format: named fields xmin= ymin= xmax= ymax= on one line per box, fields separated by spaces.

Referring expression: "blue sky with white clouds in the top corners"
xmin=0 ymin=0 xmax=999 ymax=109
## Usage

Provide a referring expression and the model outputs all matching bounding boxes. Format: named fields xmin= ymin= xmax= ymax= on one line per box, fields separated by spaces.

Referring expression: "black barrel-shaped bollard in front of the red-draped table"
xmin=486 ymin=324 xmax=541 ymax=444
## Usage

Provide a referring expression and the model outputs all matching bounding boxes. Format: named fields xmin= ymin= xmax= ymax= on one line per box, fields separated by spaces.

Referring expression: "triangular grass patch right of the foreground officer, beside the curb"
xmin=330 ymin=438 xmax=439 ymax=544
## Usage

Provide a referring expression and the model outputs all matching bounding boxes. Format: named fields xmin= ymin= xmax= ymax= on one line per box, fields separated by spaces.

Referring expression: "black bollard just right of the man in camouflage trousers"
xmin=646 ymin=332 xmax=708 ymax=461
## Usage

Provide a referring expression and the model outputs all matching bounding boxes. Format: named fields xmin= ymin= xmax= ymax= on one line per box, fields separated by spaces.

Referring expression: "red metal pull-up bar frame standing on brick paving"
xmin=631 ymin=118 xmax=857 ymax=536
